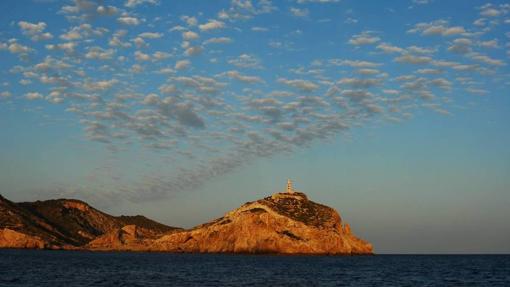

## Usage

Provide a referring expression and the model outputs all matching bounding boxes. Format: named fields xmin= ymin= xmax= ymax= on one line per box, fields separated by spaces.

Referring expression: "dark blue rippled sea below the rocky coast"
xmin=0 ymin=250 xmax=510 ymax=286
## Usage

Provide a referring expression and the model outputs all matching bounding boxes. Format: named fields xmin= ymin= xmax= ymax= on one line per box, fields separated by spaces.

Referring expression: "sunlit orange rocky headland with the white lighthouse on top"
xmin=149 ymin=193 xmax=372 ymax=255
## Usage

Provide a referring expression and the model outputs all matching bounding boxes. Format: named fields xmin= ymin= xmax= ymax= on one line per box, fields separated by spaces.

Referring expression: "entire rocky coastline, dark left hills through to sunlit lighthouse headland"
xmin=0 ymin=193 xmax=372 ymax=255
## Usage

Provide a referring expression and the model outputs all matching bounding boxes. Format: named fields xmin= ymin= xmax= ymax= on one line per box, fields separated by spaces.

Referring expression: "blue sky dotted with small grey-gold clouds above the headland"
xmin=0 ymin=0 xmax=510 ymax=253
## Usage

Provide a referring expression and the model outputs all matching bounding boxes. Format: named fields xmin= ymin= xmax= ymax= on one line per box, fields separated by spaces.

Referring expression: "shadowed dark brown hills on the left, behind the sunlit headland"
xmin=0 ymin=196 xmax=179 ymax=249
